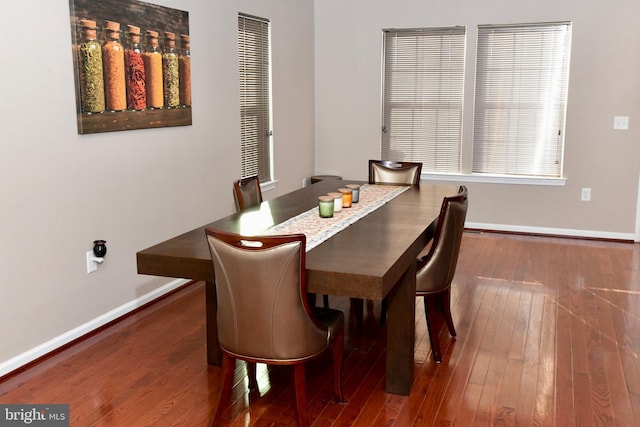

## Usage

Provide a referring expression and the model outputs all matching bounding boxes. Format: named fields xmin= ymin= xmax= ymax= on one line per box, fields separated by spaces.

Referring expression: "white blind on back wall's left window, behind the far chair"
xmin=381 ymin=27 xmax=465 ymax=172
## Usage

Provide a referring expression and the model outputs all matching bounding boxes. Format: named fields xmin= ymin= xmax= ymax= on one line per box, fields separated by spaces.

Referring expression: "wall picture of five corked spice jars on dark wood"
xmin=69 ymin=0 xmax=191 ymax=134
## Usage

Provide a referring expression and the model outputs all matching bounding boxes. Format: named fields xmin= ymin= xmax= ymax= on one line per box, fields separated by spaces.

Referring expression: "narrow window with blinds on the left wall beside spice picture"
xmin=238 ymin=14 xmax=273 ymax=182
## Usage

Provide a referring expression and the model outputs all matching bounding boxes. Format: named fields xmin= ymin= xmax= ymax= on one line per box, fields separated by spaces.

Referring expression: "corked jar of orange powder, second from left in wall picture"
xmin=102 ymin=21 xmax=127 ymax=111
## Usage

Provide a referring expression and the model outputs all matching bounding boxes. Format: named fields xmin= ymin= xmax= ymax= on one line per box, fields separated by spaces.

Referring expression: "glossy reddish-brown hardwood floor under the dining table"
xmin=0 ymin=233 xmax=640 ymax=427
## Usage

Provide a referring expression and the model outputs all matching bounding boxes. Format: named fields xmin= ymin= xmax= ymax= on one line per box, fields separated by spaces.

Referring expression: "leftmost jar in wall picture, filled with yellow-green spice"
xmin=78 ymin=19 xmax=104 ymax=114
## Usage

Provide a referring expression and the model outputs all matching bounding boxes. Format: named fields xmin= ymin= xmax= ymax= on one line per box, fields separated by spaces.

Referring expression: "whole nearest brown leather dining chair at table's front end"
xmin=206 ymin=228 xmax=344 ymax=427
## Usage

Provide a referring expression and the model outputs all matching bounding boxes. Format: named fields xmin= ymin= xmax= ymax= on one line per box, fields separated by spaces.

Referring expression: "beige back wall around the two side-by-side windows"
xmin=315 ymin=0 xmax=640 ymax=238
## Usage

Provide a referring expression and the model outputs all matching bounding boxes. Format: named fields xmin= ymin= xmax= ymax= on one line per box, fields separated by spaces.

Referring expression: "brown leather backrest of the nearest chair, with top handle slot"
xmin=206 ymin=228 xmax=329 ymax=363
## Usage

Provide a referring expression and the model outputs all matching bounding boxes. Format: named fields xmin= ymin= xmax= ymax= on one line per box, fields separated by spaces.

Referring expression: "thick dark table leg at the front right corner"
xmin=386 ymin=263 xmax=416 ymax=396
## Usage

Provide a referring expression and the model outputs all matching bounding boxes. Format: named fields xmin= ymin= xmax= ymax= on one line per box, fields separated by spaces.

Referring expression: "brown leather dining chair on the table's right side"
xmin=416 ymin=185 xmax=469 ymax=363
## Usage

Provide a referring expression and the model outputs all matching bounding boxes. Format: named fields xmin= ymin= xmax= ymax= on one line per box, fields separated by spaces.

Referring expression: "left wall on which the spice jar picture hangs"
xmin=0 ymin=0 xmax=314 ymax=375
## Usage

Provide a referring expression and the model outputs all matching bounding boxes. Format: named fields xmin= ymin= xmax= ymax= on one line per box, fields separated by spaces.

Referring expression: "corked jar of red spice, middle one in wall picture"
xmin=124 ymin=25 xmax=147 ymax=111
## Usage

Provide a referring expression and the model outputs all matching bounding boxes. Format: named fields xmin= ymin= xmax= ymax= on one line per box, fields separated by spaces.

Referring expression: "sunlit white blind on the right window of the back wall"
xmin=472 ymin=22 xmax=571 ymax=177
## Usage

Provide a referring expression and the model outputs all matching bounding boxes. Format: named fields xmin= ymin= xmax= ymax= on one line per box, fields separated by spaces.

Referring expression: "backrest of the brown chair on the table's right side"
xmin=416 ymin=185 xmax=469 ymax=293
